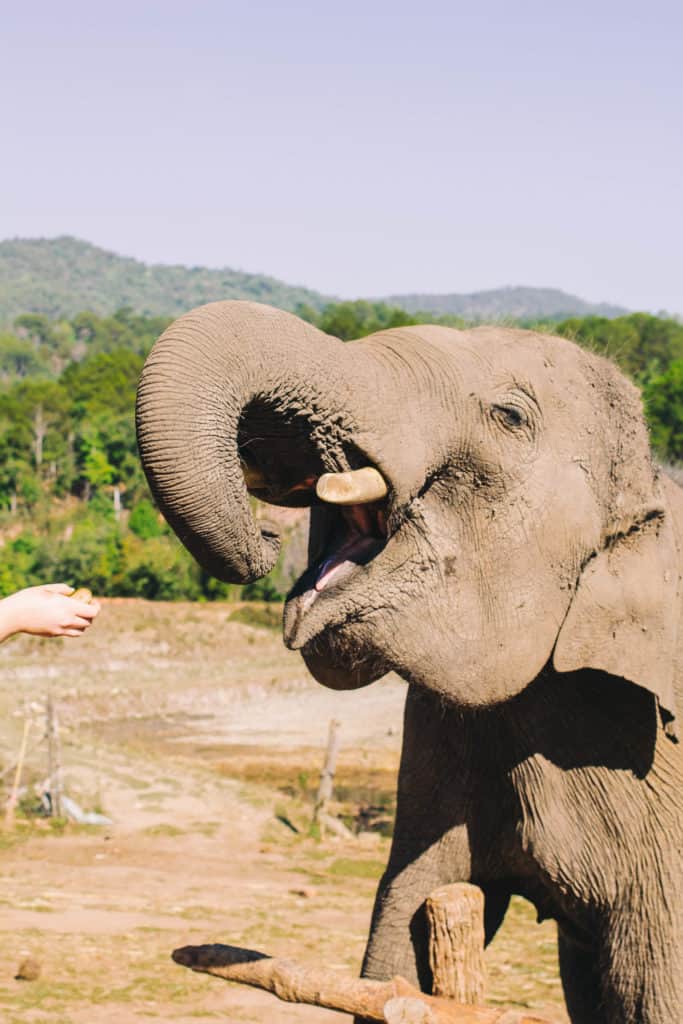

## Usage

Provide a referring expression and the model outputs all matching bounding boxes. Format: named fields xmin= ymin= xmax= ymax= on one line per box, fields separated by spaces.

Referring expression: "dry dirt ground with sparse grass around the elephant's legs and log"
xmin=0 ymin=600 xmax=567 ymax=1024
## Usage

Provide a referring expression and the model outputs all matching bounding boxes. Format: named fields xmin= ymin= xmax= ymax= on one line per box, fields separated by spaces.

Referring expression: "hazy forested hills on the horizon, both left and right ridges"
xmin=0 ymin=237 xmax=626 ymax=328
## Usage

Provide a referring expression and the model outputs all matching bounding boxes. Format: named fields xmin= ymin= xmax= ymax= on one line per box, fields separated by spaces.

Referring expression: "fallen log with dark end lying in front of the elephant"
xmin=173 ymin=944 xmax=547 ymax=1024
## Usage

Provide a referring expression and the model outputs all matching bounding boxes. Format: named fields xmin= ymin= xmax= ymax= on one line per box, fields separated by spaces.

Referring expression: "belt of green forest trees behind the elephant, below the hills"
xmin=0 ymin=301 xmax=683 ymax=601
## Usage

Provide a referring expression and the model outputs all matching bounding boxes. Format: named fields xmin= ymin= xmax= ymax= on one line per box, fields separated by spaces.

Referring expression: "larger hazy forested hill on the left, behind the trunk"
xmin=0 ymin=236 xmax=330 ymax=327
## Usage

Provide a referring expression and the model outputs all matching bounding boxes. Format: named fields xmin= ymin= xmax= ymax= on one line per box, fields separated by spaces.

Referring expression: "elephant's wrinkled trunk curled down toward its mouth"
xmin=136 ymin=302 xmax=355 ymax=583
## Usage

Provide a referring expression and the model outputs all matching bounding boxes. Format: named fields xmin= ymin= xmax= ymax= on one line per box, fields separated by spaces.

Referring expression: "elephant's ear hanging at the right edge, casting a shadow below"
xmin=553 ymin=507 xmax=679 ymax=741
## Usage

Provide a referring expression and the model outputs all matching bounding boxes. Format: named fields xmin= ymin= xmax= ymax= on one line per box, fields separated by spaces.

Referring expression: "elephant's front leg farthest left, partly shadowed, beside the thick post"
xmin=362 ymin=687 xmax=471 ymax=991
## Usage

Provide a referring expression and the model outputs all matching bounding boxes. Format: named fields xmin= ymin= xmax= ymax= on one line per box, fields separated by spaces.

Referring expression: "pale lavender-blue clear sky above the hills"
xmin=0 ymin=0 xmax=683 ymax=313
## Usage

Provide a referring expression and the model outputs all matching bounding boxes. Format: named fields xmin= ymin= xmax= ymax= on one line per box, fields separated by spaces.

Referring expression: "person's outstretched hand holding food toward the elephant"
xmin=0 ymin=583 xmax=99 ymax=642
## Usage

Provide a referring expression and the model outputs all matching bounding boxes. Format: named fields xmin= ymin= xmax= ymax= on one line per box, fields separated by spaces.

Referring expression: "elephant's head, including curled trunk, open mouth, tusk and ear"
xmin=137 ymin=302 xmax=678 ymax=737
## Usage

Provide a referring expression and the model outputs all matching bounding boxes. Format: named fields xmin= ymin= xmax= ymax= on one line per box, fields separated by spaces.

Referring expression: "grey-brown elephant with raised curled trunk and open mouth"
xmin=136 ymin=301 xmax=683 ymax=1024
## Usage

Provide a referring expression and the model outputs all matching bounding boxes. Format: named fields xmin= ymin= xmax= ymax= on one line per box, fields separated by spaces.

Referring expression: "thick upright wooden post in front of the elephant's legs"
xmin=427 ymin=882 xmax=485 ymax=1006
